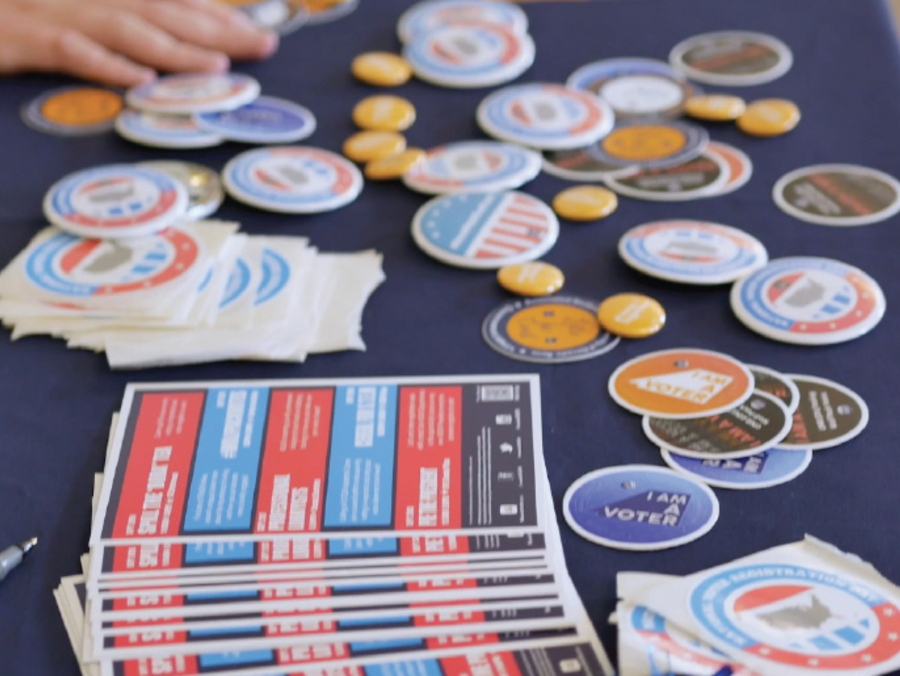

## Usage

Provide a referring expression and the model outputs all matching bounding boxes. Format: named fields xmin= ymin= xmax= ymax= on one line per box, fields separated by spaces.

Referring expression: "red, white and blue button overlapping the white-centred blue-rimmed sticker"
xmin=477 ymin=83 xmax=615 ymax=150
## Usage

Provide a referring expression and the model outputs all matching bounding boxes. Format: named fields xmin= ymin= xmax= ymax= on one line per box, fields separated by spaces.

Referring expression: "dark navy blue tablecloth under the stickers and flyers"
xmin=0 ymin=0 xmax=900 ymax=676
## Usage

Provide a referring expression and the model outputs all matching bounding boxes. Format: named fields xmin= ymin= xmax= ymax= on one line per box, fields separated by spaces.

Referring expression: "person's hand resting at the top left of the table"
xmin=0 ymin=0 xmax=278 ymax=87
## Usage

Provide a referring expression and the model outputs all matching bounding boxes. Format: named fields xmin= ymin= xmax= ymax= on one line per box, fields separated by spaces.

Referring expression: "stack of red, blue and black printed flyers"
xmin=57 ymin=375 xmax=612 ymax=676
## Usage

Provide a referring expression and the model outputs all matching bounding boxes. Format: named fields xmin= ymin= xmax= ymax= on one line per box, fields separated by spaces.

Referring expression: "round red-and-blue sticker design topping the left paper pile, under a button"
xmin=25 ymin=228 xmax=202 ymax=300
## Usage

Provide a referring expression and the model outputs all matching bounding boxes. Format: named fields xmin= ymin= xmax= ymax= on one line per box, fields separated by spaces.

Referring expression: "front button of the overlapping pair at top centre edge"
xmin=403 ymin=23 xmax=534 ymax=88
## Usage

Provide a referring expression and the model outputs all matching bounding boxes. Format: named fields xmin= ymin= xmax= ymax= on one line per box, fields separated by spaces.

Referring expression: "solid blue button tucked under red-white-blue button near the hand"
xmin=194 ymin=96 xmax=316 ymax=144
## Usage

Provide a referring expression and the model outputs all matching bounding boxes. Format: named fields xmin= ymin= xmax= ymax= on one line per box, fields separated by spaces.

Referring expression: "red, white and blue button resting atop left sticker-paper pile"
xmin=44 ymin=164 xmax=188 ymax=239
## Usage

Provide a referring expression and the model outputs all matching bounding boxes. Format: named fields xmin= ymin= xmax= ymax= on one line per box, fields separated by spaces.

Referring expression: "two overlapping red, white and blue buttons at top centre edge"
xmin=397 ymin=0 xmax=535 ymax=88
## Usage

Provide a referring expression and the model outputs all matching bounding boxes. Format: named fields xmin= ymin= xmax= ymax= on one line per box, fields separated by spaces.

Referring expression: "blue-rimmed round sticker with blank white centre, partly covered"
xmin=566 ymin=59 xmax=696 ymax=120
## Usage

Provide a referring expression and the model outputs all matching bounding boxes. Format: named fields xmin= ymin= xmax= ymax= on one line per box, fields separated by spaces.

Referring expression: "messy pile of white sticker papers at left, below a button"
xmin=0 ymin=221 xmax=384 ymax=368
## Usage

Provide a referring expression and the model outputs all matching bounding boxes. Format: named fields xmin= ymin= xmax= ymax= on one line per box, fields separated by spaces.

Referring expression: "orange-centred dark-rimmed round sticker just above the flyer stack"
xmin=481 ymin=296 xmax=619 ymax=364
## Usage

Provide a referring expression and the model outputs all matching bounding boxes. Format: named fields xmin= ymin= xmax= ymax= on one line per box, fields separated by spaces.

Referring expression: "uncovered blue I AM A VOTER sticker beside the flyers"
xmin=563 ymin=465 xmax=719 ymax=551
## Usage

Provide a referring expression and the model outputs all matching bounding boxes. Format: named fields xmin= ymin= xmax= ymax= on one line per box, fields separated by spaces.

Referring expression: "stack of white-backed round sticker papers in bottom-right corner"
xmin=611 ymin=536 xmax=900 ymax=676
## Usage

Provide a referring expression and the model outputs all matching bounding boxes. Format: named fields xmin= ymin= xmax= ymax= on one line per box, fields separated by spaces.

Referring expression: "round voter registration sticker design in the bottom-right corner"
xmin=688 ymin=562 xmax=900 ymax=676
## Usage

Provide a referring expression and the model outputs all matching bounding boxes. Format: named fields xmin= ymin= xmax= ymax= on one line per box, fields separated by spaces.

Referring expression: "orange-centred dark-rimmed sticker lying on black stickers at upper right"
xmin=593 ymin=121 xmax=709 ymax=169
